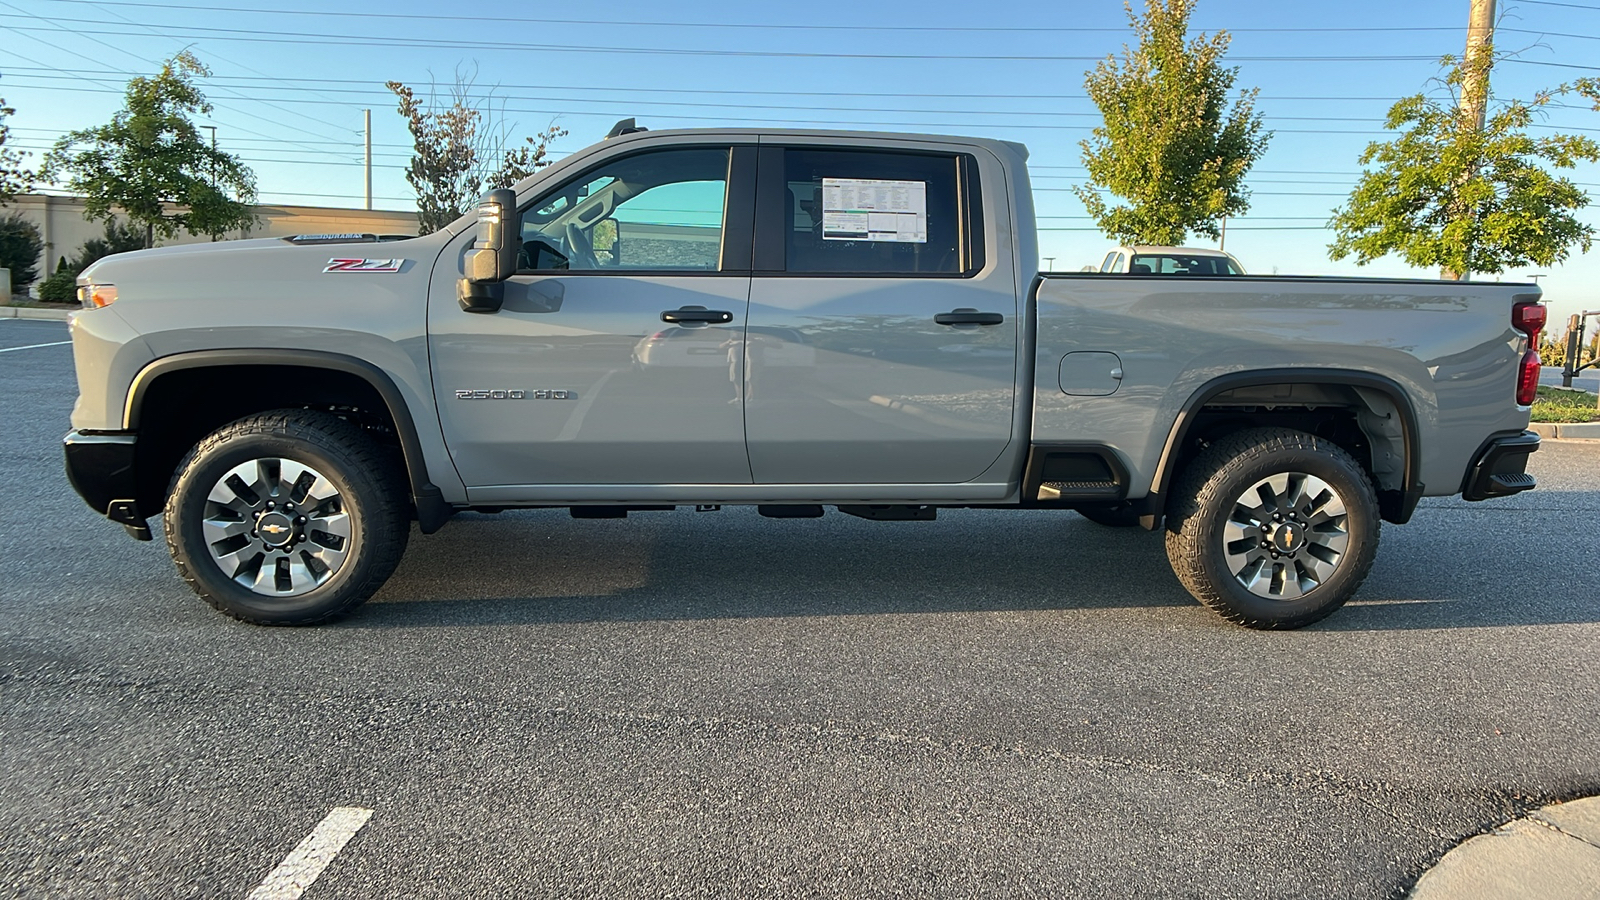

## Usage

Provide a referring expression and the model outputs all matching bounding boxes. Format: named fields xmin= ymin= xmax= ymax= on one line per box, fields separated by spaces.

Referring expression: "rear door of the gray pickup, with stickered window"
xmin=744 ymin=139 xmax=1019 ymax=485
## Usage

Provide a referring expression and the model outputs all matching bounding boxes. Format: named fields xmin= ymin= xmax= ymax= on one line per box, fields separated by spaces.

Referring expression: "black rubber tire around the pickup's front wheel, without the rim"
xmin=163 ymin=410 xmax=411 ymax=625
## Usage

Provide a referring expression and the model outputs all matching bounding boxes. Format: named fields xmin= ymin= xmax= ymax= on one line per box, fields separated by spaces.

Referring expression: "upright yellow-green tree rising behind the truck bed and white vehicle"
xmin=1075 ymin=0 xmax=1272 ymax=245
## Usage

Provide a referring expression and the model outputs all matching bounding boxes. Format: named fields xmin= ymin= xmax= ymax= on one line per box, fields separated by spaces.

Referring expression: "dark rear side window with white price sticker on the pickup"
xmin=784 ymin=147 xmax=982 ymax=275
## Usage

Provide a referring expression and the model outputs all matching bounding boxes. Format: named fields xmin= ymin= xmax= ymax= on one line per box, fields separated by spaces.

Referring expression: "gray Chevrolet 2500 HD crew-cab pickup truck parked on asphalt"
xmin=66 ymin=128 xmax=1544 ymax=628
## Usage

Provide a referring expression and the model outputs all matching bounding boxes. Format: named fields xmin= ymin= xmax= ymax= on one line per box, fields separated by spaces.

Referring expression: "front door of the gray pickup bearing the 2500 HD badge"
xmin=429 ymin=146 xmax=750 ymax=486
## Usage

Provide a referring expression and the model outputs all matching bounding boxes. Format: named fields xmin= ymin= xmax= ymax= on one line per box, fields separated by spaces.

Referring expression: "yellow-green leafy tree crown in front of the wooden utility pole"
xmin=1328 ymin=51 xmax=1600 ymax=279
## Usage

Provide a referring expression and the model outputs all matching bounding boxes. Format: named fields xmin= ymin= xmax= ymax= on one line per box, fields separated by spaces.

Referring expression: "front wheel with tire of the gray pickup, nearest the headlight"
xmin=165 ymin=410 xmax=411 ymax=625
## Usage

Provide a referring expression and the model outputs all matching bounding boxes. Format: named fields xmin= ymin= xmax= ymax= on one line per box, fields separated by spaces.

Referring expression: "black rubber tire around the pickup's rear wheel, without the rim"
xmin=1166 ymin=428 xmax=1381 ymax=629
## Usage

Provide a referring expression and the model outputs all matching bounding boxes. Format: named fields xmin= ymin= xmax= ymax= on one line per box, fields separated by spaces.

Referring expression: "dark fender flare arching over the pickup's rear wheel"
xmin=1141 ymin=368 xmax=1424 ymax=528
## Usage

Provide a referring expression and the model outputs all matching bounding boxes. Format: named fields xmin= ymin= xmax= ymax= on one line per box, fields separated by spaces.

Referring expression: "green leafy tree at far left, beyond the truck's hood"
xmin=40 ymin=50 xmax=256 ymax=247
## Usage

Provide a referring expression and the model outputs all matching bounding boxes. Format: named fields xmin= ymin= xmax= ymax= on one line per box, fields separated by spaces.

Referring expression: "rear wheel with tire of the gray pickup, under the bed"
xmin=1166 ymin=428 xmax=1379 ymax=628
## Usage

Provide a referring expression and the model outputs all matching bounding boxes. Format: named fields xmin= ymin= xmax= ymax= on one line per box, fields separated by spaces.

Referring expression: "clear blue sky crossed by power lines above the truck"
xmin=0 ymin=0 xmax=1600 ymax=315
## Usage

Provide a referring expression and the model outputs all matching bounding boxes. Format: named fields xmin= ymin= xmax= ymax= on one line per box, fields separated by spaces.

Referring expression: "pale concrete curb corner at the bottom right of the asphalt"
xmin=1410 ymin=798 xmax=1600 ymax=900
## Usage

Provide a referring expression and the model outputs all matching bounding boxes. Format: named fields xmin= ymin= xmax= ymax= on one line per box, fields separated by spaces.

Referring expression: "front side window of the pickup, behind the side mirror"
xmin=518 ymin=147 xmax=728 ymax=272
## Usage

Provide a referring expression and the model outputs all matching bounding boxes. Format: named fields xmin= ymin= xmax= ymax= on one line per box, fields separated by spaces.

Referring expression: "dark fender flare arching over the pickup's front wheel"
xmin=123 ymin=349 xmax=453 ymax=535
